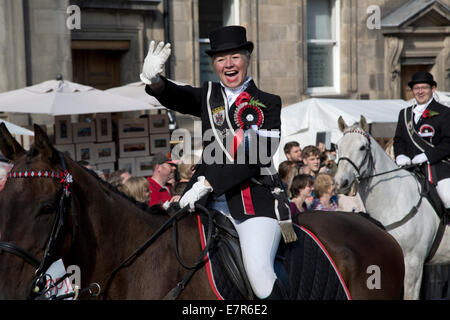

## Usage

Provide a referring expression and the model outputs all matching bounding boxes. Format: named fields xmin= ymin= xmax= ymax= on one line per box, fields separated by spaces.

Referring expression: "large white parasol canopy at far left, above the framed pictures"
xmin=0 ymin=80 xmax=155 ymax=116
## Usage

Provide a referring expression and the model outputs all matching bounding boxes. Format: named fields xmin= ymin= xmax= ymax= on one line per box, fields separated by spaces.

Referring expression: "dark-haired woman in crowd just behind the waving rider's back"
xmin=289 ymin=174 xmax=314 ymax=218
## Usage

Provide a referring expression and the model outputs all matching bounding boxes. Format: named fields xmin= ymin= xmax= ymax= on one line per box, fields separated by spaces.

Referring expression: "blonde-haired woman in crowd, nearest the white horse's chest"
xmin=311 ymin=173 xmax=338 ymax=211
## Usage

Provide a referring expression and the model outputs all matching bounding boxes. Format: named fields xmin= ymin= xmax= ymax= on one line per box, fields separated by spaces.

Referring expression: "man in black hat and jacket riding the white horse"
xmin=394 ymin=71 xmax=450 ymax=211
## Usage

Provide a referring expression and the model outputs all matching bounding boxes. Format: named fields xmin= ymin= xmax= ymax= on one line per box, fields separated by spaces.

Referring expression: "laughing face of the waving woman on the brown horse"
xmin=213 ymin=51 xmax=250 ymax=88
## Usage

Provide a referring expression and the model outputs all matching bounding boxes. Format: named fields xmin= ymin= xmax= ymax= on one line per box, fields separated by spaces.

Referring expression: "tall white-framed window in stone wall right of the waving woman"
xmin=306 ymin=0 xmax=340 ymax=95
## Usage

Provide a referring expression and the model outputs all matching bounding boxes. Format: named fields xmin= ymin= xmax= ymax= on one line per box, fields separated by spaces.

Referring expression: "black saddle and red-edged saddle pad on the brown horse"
xmin=199 ymin=210 xmax=350 ymax=300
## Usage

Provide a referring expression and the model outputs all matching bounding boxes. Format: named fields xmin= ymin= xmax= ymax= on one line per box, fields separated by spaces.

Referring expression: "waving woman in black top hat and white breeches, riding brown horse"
xmin=141 ymin=26 xmax=296 ymax=299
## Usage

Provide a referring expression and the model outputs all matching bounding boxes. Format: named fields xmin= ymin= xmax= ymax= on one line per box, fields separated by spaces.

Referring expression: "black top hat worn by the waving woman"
xmin=205 ymin=26 xmax=253 ymax=57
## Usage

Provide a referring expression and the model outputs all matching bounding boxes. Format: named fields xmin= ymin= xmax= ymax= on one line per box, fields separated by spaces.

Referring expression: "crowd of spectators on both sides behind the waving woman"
xmin=65 ymin=136 xmax=364 ymax=217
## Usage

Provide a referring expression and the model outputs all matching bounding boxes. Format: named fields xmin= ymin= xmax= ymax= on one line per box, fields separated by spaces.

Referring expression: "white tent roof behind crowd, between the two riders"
xmin=274 ymin=98 xmax=408 ymax=167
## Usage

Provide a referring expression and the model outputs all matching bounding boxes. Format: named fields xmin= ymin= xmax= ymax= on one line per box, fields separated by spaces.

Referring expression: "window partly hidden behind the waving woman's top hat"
xmin=198 ymin=0 xmax=239 ymax=84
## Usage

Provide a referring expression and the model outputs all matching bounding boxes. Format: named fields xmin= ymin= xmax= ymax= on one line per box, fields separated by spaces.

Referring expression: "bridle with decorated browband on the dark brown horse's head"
xmin=0 ymin=153 xmax=76 ymax=298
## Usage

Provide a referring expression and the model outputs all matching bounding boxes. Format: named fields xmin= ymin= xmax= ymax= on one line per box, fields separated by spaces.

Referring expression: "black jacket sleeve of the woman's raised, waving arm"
xmin=145 ymin=76 xmax=202 ymax=117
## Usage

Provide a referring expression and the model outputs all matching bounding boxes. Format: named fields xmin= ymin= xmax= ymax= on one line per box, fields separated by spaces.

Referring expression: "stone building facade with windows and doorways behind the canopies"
xmin=0 ymin=0 xmax=450 ymax=129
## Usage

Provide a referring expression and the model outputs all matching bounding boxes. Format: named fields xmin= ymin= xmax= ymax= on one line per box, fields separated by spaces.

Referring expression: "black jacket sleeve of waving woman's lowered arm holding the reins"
xmin=205 ymin=95 xmax=281 ymax=195
